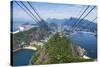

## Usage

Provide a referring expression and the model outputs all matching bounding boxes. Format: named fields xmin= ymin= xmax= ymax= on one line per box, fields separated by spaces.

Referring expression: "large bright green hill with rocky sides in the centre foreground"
xmin=32 ymin=34 xmax=92 ymax=64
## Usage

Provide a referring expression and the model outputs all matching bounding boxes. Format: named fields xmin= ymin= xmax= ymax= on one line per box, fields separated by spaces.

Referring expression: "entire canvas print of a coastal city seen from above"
xmin=10 ymin=1 xmax=98 ymax=66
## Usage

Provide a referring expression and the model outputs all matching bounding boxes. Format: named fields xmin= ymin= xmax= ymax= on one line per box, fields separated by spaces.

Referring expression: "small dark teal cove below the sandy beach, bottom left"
xmin=12 ymin=49 xmax=34 ymax=66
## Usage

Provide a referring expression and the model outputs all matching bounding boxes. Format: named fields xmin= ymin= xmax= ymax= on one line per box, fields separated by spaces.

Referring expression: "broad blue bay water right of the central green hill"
xmin=69 ymin=32 xmax=97 ymax=58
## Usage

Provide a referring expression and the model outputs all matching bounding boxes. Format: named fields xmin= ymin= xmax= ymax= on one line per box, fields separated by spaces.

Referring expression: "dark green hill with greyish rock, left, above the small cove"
xmin=12 ymin=27 xmax=48 ymax=49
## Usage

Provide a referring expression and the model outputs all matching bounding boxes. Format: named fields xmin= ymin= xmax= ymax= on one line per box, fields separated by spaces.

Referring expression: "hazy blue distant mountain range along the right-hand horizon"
xmin=47 ymin=17 xmax=97 ymax=30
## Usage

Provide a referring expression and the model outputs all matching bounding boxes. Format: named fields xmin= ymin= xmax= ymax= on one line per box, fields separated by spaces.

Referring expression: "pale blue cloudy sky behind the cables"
xmin=13 ymin=2 xmax=97 ymax=22
